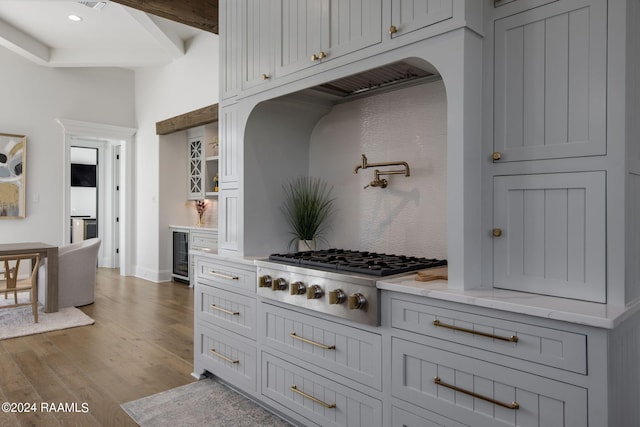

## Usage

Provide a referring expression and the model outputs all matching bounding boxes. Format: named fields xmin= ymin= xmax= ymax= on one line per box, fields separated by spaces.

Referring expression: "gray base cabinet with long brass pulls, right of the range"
xmin=383 ymin=292 xmax=607 ymax=427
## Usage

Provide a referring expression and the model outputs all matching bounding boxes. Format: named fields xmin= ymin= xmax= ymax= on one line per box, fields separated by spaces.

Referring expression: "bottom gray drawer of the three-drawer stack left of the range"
xmin=194 ymin=323 xmax=257 ymax=392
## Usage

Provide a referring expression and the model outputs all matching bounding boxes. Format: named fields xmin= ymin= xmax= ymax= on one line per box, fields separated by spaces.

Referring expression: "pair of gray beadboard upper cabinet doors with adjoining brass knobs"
xmin=276 ymin=0 xmax=382 ymax=76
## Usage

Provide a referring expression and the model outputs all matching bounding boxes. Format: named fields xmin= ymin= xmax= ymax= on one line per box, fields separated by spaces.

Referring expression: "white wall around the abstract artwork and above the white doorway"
xmin=0 ymin=47 xmax=135 ymax=245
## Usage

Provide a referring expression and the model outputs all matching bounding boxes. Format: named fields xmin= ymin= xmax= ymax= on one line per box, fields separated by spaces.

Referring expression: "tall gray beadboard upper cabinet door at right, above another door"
xmin=494 ymin=0 xmax=607 ymax=162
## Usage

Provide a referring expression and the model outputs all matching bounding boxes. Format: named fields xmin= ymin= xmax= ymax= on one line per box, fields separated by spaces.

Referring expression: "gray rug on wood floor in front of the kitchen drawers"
xmin=120 ymin=378 xmax=291 ymax=427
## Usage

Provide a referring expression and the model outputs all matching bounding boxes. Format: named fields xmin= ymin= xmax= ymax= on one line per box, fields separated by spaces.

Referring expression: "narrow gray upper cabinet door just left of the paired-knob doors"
xmin=242 ymin=0 xmax=276 ymax=89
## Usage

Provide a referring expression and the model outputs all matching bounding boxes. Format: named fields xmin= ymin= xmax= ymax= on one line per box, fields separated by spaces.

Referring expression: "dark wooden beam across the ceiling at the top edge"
xmin=112 ymin=0 xmax=218 ymax=34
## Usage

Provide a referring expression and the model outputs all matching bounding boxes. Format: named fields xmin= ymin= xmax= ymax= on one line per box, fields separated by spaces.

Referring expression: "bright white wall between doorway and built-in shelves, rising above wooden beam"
xmin=135 ymin=33 xmax=219 ymax=281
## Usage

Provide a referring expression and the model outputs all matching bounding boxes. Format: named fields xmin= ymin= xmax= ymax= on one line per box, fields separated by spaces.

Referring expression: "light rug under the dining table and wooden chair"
xmin=0 ymin=294 xmax=94 ymax=340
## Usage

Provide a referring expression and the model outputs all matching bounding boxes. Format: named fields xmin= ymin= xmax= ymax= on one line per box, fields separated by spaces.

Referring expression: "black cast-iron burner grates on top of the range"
xmin=269 ymin=249 xmax=447 ymax=276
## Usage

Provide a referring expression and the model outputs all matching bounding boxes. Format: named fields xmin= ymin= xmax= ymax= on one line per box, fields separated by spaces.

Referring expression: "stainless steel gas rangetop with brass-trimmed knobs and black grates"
xmin=256 ymin=249 xmax=447 ymax=326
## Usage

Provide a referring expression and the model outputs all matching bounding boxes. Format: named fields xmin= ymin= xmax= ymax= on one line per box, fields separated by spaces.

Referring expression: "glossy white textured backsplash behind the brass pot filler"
xmin=309 ymin=81 xmax=447 ymax=258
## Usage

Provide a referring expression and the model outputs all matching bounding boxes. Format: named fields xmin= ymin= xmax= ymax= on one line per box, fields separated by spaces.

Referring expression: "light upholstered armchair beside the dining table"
xmin=58 ymin=238 xmax=101 ymax=308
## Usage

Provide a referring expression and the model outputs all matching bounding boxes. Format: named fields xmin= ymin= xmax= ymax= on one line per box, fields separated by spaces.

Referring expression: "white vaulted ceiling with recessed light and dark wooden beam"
xmin=0 ymin=0 xmax=218 ymax=68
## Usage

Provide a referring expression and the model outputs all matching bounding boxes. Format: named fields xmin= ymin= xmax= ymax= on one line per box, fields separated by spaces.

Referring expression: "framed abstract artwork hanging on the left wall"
xmin=0 ymin=133 xmax=27 ymax=219
